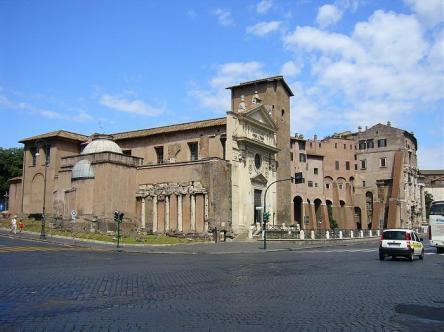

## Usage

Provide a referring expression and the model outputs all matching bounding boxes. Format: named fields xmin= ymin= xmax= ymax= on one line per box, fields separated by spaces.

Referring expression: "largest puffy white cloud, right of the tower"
xmin=283 ymin=10 xmax=444 ymax=130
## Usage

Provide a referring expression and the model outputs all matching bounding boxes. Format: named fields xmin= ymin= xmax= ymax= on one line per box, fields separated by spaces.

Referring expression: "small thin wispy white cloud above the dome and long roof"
xmin=99 ymin=94 xmax=165 ymax=116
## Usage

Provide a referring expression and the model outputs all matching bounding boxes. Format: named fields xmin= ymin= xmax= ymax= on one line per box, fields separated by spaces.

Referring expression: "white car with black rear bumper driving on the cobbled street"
xmin=379 ymin=229 xmax=424 ymax=262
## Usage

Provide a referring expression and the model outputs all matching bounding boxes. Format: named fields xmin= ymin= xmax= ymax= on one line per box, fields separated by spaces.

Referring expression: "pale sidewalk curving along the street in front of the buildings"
xmin=0 ymin=228 xmax=379 ymax=255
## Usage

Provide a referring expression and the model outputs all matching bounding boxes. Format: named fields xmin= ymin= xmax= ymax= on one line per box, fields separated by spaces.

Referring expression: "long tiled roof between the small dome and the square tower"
xmin=112 ymin=118 xmax=227 ymax=140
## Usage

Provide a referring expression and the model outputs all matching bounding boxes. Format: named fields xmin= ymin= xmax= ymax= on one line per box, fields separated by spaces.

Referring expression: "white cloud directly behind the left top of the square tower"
xmin=188 ymin=61 xmax=266 ymax=112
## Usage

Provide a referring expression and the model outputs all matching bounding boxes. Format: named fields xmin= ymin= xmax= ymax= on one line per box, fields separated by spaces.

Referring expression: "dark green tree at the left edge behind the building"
xmin=0 ymin=148 xmax=23 ymax=198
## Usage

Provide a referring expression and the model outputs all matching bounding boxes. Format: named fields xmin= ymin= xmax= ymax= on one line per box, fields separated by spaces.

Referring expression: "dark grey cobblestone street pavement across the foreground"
xmin=0 ymin=237 xmax=444 ymax=332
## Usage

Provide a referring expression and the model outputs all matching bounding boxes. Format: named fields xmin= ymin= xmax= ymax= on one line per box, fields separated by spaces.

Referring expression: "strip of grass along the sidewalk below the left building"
xmin=0 ymin=220 xmax=208 ymax=244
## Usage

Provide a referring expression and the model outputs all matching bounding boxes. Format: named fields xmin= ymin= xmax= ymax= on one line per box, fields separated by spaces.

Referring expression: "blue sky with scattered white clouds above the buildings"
xmin=0 ymin=0 xmax=444 ymax=169
